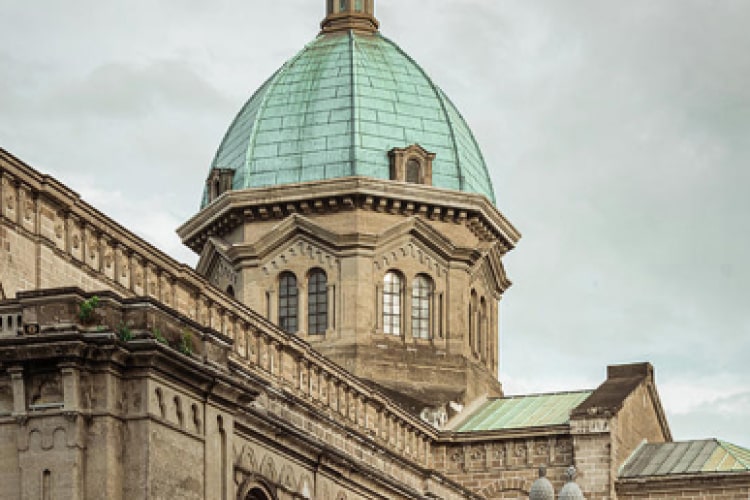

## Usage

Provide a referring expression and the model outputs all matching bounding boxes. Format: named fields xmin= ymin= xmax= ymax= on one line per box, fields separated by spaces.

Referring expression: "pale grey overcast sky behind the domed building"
xmin=0 ymin=0 xmax=750 ymax=447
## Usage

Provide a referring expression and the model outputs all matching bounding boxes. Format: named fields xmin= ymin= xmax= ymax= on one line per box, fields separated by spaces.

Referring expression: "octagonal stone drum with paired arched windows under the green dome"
xmin=178 ymin=177 xmax=520 ymax=410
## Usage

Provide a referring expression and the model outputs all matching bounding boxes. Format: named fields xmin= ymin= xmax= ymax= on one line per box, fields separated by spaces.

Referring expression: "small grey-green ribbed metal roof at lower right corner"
xmin=620 ymin=439 xmax=750 ymax=478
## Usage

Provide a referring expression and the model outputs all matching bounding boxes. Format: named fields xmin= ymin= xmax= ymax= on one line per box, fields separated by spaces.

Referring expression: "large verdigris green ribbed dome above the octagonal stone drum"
xmin=202 ymin=31 xmax=495 ymax=206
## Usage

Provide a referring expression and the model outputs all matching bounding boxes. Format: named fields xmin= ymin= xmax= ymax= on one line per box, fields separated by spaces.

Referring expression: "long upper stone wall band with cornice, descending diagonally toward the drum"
xmin=0 ymin=149 xmax=437 ymax=467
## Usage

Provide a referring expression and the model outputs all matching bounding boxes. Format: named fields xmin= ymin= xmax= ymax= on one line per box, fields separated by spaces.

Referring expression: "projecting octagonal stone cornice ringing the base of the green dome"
xmin=177 ymin=177 xmax=521 ymax=252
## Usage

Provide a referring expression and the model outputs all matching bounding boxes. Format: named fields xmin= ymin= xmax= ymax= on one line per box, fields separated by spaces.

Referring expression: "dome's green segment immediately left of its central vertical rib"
xmin=242 ymin=34 xmax=352 ymax=187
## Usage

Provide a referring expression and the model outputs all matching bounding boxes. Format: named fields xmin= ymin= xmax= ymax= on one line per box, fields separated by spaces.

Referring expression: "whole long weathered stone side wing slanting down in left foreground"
xmin=0 ymin=152 xmax=482 ymax=500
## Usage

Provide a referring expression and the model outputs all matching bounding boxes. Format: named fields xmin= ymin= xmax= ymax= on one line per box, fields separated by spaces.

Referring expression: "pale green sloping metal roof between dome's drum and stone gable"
xmin=458 ymin=391 xmax=591 ymax=432
